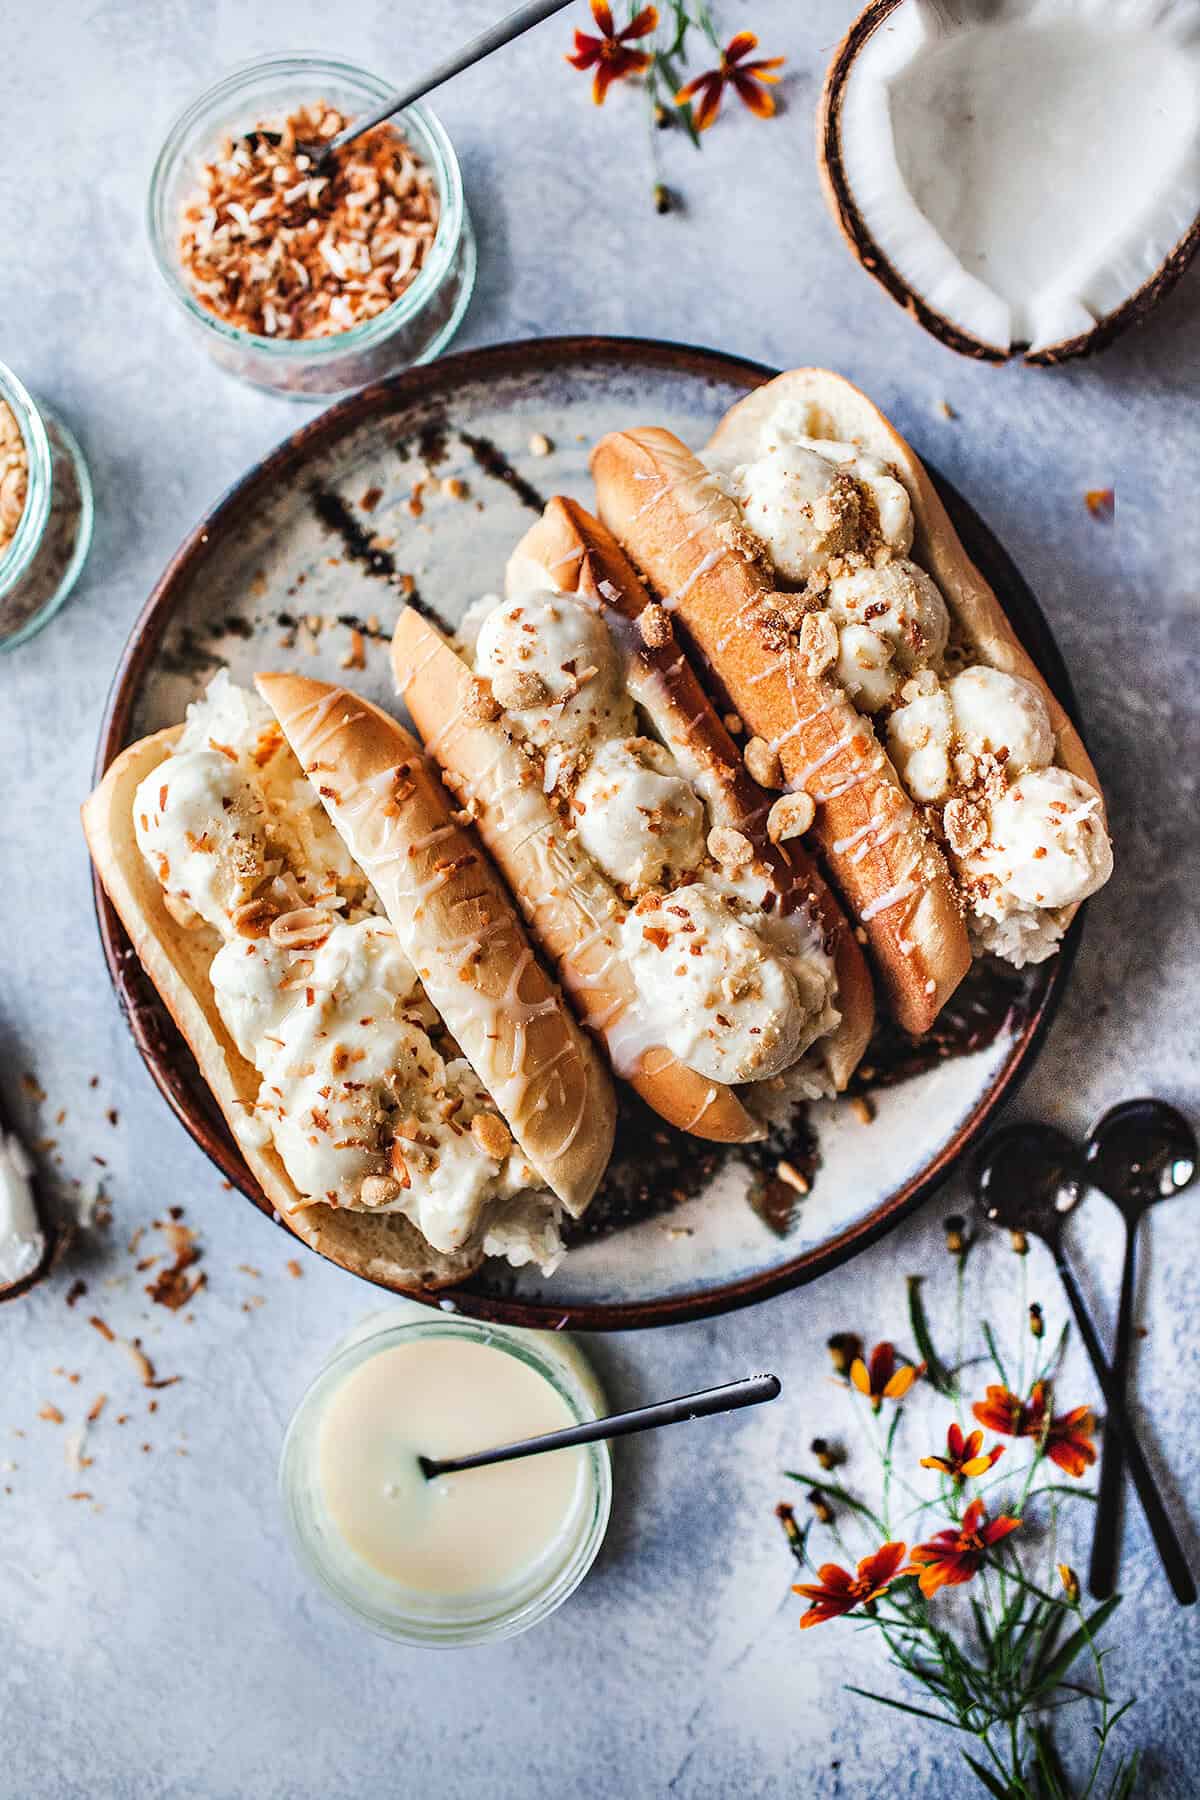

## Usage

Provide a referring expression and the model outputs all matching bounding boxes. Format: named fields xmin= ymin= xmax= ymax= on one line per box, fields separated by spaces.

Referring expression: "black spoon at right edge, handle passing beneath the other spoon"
xmin=1085 ymin=1100 xmax=1196 ymax=1600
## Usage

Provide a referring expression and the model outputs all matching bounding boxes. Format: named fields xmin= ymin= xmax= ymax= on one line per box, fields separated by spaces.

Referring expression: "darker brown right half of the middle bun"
xmin=509 ymin=497 xmax=874 ymax=1093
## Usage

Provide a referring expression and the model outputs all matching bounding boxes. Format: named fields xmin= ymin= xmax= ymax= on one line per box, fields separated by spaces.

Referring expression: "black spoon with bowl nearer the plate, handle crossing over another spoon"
xmin=972 ymin=1125 xmax=1196 ymax=1606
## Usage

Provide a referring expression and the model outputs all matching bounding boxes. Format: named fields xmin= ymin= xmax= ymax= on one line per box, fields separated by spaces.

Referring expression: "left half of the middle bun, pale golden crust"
xmin=392 ymin=607 xmax=761 ymax=1143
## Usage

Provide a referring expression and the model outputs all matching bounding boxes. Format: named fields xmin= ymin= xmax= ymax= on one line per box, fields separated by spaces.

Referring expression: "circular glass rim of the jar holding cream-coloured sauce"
xmin=279 ymin=1314 xmax=612 ymax=1649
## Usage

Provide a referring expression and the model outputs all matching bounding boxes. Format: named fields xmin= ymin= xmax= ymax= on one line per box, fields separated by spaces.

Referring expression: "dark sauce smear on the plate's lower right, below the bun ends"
xmin=565 ymin=959 xmax=1034 ymax=1244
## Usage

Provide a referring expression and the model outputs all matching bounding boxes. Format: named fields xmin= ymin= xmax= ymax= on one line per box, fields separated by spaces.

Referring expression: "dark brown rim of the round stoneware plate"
xmin=92 ymin=337 xmax=1083 ymax=1330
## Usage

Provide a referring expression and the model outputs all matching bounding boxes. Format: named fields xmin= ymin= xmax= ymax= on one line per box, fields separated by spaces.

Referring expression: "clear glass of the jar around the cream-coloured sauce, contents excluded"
xmin=279 ymin=1305 xmax=612 ymax=1649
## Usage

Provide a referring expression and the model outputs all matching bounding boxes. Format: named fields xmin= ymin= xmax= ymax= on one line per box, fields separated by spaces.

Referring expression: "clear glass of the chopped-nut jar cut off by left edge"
xmin=0 ymin=364 xmax=94 ymax=650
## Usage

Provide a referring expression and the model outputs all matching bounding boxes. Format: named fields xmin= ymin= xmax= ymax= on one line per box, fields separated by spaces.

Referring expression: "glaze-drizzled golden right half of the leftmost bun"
xmin=255 ymin=675 xmax=617 ymax=1219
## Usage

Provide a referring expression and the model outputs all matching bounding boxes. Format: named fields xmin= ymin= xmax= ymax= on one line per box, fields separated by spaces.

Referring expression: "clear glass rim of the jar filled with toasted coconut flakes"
xmin=146 ymin=50 xmax=466 ymax=365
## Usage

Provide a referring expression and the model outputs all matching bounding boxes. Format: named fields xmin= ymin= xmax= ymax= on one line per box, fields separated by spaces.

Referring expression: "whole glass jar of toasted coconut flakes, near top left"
xmin=148 ymin=54 xmax=475 ymax=400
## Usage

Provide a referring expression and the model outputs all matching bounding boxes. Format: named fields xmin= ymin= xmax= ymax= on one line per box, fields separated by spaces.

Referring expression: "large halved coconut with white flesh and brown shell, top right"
xmin=817 ymin=0 xmax=1200 ymax=364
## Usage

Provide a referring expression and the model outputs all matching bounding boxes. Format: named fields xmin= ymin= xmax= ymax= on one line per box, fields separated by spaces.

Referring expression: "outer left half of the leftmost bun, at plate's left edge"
xmin=83 ymin=725 xmax=482 ymax=1292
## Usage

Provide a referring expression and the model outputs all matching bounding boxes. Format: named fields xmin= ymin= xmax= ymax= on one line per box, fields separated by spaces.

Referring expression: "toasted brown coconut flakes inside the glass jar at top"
xmin=180 ymin=101 xmax=437 ymax=338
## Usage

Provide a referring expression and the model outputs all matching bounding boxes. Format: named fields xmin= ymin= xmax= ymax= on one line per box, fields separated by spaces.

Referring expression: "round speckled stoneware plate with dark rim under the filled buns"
xmin=97 ymin=338 xmax=1074 ymax=1328
